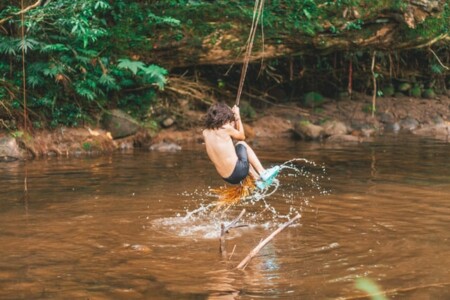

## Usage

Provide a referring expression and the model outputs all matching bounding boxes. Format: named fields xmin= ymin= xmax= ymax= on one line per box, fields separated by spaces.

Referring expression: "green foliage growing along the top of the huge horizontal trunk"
xmin=145 ymin=0 xmax=450 ymax=54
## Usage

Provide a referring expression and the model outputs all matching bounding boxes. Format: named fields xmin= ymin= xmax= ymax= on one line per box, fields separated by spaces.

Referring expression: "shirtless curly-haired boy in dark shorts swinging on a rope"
xmin=203 ymin=103 xmax=279 ymax=189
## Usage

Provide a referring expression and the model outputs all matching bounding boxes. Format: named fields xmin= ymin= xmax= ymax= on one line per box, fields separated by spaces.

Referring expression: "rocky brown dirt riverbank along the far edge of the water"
xmin=0 ymin=94 xmax=450 ymax=161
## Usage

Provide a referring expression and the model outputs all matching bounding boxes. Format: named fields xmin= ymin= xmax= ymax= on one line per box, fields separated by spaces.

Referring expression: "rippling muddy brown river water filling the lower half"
xmin=0 ymin=136 xmax=450 ymax=299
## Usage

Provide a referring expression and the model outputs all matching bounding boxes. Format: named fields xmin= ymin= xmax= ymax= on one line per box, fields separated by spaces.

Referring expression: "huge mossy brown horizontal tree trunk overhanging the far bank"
xmin=146 ymin=0 xmax=450 ymax=69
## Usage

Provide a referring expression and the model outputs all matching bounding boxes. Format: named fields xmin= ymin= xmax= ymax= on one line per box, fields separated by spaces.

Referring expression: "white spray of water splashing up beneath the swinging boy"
xmin=152 ymin=158 xmax=329 ymax=238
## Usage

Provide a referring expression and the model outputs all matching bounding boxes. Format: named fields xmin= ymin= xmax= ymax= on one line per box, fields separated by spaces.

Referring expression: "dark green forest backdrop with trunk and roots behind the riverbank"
xmin=0 ymin=0 xmax=450 ymax=136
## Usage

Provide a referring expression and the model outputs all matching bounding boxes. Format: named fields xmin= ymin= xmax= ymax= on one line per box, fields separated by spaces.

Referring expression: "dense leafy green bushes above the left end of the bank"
xmin=0 ymin=0 xmax=170 ymax=126
